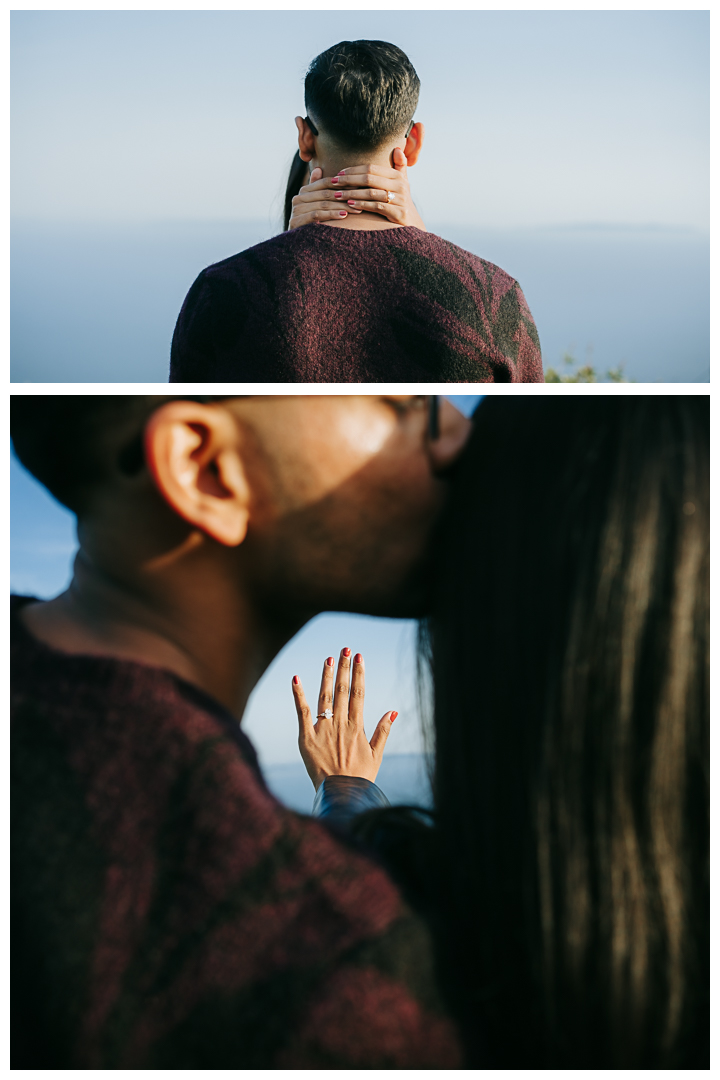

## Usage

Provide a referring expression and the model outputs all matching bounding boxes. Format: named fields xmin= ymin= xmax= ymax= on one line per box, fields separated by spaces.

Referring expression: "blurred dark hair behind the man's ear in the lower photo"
xmin=10 ymin=394 xmax=227 ymax=513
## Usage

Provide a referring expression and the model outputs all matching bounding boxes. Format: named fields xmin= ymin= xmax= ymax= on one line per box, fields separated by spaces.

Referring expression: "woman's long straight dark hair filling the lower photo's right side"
xmin=426 ymin=395 xmax=709 ymax=1068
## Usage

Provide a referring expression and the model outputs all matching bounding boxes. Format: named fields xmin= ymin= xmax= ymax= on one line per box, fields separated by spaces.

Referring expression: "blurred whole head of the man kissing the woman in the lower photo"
xmin=12 ymin=395 xmax=466 ymax=615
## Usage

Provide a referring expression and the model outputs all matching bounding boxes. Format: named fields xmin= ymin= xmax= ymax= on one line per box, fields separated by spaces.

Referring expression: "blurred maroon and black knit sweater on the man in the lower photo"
xmin=11 ymin=598 xmax=460 ymax=1069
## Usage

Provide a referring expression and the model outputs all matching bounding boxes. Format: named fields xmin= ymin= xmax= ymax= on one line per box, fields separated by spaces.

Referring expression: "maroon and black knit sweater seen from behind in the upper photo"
xmin=169 ymin=225 xmax=543 ymax=382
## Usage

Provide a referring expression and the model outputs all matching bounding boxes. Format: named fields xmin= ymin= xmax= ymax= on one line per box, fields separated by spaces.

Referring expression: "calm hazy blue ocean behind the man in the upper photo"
xmin=11 ymin=221 xmax=709 ymax=382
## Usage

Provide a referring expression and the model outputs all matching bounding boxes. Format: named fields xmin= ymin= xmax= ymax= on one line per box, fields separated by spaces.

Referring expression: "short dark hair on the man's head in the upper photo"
xmin=305 ymin=41 xmax=420 ymax=150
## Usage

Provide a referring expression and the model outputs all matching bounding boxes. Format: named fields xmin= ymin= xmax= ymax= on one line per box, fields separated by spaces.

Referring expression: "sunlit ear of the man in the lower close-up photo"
xmin=145 ymin=401 xmax=250 ymax=548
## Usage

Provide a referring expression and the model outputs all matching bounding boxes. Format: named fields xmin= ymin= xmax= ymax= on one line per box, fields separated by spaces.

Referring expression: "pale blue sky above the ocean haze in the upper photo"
xmin=12 ymin=11 xmax=709 ymax=230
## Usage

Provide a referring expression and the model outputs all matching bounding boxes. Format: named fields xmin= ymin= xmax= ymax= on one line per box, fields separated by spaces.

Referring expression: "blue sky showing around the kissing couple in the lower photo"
xmin=10 ymin=394 xmax=480 ymax=765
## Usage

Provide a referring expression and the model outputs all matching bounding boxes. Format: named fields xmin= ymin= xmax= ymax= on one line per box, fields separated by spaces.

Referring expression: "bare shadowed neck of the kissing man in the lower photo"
xmin=21 ymin=552 xmax=314 ymax=719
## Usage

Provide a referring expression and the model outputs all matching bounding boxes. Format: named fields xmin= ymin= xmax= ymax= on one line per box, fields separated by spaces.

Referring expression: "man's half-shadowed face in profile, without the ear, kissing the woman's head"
xmin=233 ymin=394 xmax=470 ymax=616
